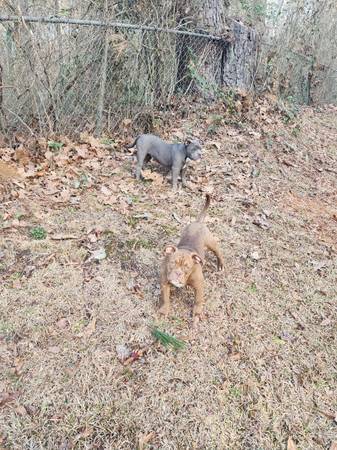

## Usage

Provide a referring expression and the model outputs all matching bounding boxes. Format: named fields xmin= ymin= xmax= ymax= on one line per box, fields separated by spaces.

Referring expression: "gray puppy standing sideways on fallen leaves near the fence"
xmin=127 ymin=134 xmax=201 ymax=189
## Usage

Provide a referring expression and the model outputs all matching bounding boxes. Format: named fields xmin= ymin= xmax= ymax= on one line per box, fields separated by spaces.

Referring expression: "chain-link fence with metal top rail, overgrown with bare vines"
xmin=0 ymin=17 xmax=255 ymax=139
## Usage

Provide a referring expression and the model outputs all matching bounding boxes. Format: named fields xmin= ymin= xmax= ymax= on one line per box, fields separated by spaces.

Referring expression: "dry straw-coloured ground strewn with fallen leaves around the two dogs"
xmin=0 ymin=99 xmax=337 ymax=450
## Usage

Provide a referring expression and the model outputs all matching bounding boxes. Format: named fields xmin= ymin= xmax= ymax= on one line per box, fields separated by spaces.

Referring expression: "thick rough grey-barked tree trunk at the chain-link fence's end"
xmin=177 ymin=0 xmax=257 ymax=97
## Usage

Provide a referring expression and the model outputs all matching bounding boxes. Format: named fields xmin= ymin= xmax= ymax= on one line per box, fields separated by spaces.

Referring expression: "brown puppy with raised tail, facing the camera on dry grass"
xmin=159 ymin=194 xmax=224 ymax=324
